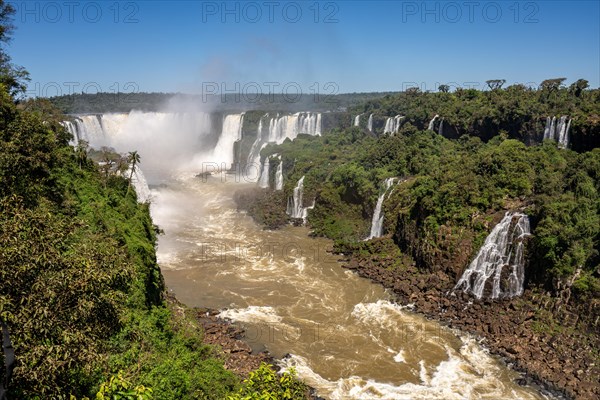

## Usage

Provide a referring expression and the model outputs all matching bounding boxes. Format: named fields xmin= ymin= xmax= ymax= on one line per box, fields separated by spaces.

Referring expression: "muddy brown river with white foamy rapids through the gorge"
xmin=152 ymin=173 xmax=546 ymax=400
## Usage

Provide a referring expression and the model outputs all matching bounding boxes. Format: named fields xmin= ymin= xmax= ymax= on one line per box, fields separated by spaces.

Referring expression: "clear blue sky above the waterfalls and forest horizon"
xmin=7 ymin=0 xmax=600 ymax=95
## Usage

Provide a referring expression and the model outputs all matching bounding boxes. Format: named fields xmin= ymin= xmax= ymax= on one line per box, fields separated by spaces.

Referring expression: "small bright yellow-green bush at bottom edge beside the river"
xmin=227 ymin=363 xmax=308 ymax=400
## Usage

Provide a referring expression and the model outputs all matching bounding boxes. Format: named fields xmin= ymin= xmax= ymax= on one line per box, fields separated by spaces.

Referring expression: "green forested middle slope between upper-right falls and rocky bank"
xmin=248 ymin=101 xmax=600 ymax=299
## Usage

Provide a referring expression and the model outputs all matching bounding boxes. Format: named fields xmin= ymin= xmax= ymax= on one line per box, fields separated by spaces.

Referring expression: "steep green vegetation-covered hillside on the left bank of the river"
xmin=0 ymin=86 xmax=246 ymax=399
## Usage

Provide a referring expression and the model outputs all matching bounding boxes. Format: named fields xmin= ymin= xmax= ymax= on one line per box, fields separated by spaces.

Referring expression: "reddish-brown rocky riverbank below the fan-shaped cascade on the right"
xmin=342 ymin=239 xmax=600 ymax=399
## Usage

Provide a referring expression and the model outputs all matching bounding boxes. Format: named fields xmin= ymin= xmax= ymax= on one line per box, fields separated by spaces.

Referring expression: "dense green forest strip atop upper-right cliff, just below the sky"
xmin=349 ymin=78 xmax=600 ymax=151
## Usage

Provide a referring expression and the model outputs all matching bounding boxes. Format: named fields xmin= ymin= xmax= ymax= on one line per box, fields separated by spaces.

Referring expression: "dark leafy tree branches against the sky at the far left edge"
xmin=0 ymin=0 xmax=29 ymax=98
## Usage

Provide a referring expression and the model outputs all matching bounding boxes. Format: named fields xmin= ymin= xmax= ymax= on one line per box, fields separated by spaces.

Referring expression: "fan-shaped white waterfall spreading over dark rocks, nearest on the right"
xmin=454 ymin=212 xmax=530 ymax=299
